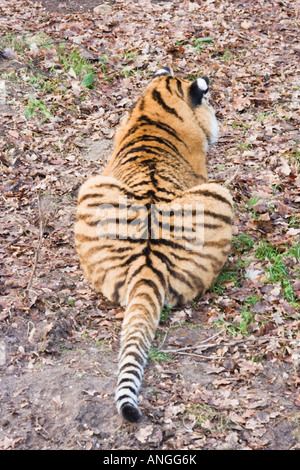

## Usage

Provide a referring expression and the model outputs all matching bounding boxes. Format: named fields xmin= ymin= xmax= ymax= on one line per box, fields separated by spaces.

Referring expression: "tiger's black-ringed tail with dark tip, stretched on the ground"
xmin=115 ymin=276 xmax=164 ymax=423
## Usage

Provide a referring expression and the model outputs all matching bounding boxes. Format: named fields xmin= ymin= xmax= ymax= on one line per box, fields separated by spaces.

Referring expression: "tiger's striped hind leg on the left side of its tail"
xmin=75 ymin=175 xmax=142 ymax=305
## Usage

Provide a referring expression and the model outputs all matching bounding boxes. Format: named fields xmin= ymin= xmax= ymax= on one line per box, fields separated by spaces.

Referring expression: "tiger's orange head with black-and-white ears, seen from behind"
xmin=115 ymin=67 xmax=219 ymax=162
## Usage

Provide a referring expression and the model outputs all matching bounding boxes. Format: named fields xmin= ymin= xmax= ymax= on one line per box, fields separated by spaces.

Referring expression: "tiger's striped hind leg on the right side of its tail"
xmin=167 ymin=183 xmax=233 ymax=305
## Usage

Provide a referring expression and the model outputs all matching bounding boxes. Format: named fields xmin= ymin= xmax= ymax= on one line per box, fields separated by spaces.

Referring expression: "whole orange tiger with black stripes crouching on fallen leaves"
xmin=75 ymin=66 xmax=233 ymax=423
